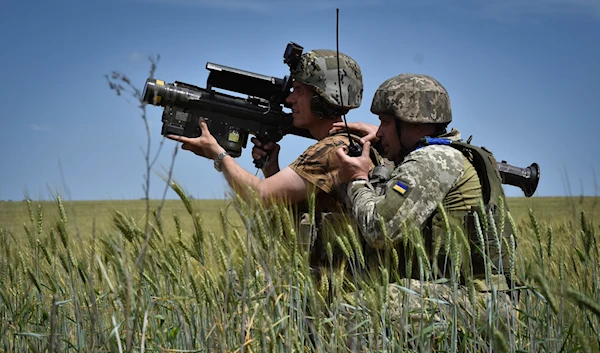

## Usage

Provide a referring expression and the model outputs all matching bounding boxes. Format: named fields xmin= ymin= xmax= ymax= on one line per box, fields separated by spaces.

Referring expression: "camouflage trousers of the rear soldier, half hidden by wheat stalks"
xmin=338 ymin=279 xmax=517 ymax=352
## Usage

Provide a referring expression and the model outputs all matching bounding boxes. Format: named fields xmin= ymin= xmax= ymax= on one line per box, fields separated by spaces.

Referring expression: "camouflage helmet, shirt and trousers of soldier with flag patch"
xmin=344 ymin=74 xmax=514 ymax=346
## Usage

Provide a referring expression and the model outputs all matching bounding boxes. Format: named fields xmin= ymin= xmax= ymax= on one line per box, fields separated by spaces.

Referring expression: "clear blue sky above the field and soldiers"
xmin=0 ymin=0 xmax=600 ymax=200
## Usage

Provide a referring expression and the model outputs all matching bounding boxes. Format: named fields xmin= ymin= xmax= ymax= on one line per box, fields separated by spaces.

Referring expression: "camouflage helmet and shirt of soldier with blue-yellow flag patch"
xmin=348 ymin=74 xmax=508 ymax=278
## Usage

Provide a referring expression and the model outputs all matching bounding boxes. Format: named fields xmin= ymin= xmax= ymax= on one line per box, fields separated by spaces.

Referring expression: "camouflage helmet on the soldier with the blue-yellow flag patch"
xmin=371 ymin=74 xmax=452 ymax=123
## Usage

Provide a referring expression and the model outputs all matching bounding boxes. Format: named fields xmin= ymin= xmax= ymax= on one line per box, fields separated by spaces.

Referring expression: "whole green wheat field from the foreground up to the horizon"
xmin=0 ymin=197 xmax=600 ymax=352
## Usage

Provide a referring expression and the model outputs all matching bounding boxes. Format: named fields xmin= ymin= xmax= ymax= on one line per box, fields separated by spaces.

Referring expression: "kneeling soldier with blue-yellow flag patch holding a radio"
xmin=333 ymin=74 xmax=514 ymax=348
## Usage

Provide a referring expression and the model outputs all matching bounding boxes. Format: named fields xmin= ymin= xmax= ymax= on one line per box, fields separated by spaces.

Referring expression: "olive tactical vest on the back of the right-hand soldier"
xmin=421 ymin=138 xmax=516 ymax=291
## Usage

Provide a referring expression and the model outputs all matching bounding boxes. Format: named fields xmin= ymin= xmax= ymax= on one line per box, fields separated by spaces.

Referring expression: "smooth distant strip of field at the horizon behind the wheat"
xmin=0 ymin=197 xmax=600 ymax=239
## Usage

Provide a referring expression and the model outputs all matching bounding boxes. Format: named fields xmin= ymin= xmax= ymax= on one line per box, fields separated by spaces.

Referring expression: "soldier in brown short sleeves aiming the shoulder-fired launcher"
xmin=167 ymin=49 xmax=380 ymax=232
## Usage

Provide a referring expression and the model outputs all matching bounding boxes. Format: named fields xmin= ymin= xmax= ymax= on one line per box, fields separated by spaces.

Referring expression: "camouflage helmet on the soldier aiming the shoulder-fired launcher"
xmin=291 ymin=49 xmax=363 ymax=109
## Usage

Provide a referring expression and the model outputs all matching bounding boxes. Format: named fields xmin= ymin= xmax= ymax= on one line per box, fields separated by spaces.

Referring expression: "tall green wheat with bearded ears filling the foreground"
xmin=0 ymin=183 xmax=600 ymax=352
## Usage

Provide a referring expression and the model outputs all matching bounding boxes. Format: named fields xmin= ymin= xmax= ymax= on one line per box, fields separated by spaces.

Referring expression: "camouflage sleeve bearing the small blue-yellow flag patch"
xmin=348 ymin=130 xmax=465 ymax=248
